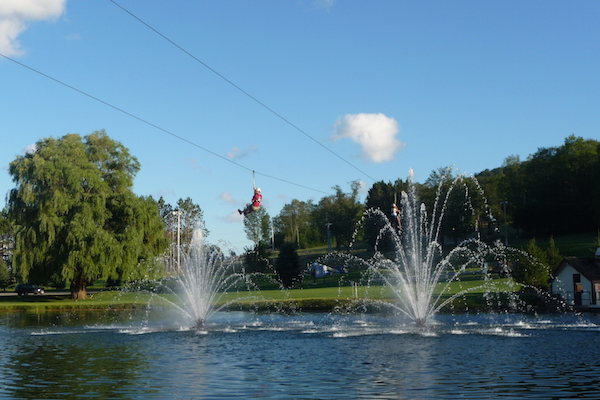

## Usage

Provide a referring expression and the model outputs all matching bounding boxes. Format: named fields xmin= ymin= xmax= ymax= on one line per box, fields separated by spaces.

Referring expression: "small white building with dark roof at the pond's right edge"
xmin=550 ymin=248 xmax=600 ymax=311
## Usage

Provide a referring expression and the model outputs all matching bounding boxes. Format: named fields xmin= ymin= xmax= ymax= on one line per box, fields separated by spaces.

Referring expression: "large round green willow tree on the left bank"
xmin=8 ymin=131 xmax=168 ymax=299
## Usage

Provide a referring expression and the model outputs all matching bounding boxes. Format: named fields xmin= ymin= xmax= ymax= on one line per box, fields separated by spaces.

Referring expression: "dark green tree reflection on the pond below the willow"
xmin=2 ymin=324 xmax=148 ymax=398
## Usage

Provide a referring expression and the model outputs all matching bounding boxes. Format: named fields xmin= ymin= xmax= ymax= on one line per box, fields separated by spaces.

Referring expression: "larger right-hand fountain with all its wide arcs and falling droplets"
xmin=323 ymin=170 xmax=526 ymax=327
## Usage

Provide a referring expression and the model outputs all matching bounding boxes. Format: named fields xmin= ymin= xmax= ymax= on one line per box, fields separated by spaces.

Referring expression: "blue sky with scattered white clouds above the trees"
xmin=0 ymin=0 xmax=600 ymax=252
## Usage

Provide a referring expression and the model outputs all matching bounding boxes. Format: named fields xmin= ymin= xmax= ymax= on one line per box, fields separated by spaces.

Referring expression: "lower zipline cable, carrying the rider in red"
xmin=0 ymin=53 xmax=331 ymax=195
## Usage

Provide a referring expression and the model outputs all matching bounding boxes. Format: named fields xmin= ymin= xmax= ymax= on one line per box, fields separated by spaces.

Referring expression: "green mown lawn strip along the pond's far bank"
xmin=0 ymin=272 xmax=520 ymax=312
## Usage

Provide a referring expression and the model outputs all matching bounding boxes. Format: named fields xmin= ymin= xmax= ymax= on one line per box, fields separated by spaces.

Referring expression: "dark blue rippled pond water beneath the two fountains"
xmin=0 ymin=313 xmax=600 ymax=399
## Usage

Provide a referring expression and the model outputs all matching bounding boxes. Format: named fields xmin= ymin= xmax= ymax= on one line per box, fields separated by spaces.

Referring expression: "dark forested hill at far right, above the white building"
xmin=476 ymin=135 xmax=600 ymax=235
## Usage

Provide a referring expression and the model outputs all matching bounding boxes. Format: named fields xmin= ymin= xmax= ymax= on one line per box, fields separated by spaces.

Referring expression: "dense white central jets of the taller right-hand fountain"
xmin=370 ymin=170 xmax=502 ymax=325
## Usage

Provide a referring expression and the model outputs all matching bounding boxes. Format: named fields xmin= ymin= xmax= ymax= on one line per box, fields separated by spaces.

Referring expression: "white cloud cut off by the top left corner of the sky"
xmin=0 ymin=0 xmax=67 ymax=56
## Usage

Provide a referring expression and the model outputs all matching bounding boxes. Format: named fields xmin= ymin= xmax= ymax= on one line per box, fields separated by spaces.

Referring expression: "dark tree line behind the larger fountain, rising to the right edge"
xmin=273 ymin=136 xmax=600 ymax=250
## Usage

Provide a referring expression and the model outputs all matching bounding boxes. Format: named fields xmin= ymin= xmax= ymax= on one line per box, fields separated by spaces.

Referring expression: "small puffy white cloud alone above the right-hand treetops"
xmin=331 ymin=113 xmax=404 ymax=163
